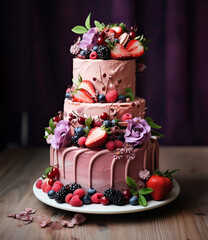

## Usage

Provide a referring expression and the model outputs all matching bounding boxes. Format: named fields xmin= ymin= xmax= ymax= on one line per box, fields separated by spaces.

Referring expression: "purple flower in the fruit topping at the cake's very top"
xmin=79 ymin=28 xmax=98 ymax=50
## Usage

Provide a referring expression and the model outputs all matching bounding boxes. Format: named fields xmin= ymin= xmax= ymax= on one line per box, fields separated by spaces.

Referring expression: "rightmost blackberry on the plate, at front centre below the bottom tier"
xmin=104 ymin=188 xmax=125 ymax=206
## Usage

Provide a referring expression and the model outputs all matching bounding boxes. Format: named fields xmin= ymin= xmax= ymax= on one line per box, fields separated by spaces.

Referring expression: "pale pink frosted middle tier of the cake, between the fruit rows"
xmin=64 ymin=98 xmax=146 ymax=121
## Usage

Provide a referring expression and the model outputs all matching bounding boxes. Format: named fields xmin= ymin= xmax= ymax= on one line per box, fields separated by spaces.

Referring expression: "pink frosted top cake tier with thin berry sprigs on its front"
xmin=73 ymin=58 xmax=136 ymax=94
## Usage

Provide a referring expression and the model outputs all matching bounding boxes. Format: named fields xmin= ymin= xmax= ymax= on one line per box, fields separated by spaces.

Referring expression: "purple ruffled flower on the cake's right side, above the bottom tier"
xmin=124 ymin=117 xmax=151 ymax=146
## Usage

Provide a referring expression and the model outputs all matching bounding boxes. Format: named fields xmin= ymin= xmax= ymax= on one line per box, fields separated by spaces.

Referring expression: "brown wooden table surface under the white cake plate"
xmin=0 ymin=147 xmax=208 ymax=240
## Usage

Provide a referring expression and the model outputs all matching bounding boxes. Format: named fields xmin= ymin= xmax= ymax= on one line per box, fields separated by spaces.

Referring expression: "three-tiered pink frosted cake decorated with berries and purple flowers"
xmin=39 ymin=15 xmax=167 ymax=205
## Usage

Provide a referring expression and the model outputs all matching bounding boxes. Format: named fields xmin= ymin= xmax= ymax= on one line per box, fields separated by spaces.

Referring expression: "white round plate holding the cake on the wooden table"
xmin=33 ymin=180 xmax=180 ymax=214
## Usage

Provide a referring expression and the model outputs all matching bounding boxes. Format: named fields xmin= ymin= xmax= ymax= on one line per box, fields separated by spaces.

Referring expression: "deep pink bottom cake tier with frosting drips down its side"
xmin=50 ymin=138 xmax=159 ymax=192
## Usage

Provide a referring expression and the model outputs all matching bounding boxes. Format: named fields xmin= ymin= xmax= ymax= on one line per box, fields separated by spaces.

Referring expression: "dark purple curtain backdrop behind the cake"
xmin=0 ymin=0 xmax=208 ymax=146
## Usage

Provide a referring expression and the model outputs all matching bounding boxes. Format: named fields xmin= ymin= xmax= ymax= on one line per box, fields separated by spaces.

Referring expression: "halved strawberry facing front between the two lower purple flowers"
xmin=85 ymin=127 xmax=108 ymax=148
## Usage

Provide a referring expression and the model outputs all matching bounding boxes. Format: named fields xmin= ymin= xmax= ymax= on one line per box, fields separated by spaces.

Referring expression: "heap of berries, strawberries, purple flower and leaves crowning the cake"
xmin=70 ymin=13 xmax=150 ymax=60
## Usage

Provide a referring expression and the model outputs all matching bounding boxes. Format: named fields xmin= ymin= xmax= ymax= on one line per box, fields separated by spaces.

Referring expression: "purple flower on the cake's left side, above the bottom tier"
xmin=50 ymin=120 xmax=71 ymax=149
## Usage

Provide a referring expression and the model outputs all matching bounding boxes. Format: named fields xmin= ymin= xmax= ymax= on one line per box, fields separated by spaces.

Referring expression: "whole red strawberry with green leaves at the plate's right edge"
xmin=146 ymin=169 xmax=179 ymax=201
